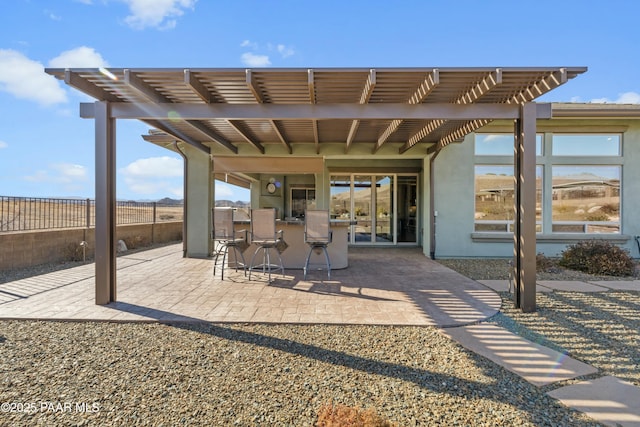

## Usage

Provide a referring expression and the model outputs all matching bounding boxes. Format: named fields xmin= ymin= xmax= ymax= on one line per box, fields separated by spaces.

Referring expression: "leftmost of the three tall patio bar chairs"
xmin=212 ymin=208 xmax=248 ymax=280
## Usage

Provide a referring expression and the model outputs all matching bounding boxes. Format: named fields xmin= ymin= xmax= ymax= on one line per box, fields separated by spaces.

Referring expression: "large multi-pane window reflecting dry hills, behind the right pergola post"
xmin=474 ymin=133 xmax=622 ymax=234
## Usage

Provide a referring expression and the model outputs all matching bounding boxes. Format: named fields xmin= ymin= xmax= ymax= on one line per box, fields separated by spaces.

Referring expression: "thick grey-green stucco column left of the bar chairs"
xmin=183 ymin=145 xmax=214 ymax=258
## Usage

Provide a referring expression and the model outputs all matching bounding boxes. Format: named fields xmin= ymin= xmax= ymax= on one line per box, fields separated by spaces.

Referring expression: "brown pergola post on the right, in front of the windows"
xmin=513 ymin=102 xmax=537 ymax=313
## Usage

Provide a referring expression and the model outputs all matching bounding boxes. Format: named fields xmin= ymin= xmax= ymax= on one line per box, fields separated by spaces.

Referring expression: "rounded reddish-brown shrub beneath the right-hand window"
xmin=559 ymin=240 xmax=635 ymax=276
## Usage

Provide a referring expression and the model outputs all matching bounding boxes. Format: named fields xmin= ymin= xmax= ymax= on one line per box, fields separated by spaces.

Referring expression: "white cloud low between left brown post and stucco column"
xmin=119 ymin=156 xmax=183 ymax=197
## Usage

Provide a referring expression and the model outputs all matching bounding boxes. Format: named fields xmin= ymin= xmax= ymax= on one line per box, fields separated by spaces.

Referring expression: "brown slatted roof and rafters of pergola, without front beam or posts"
xmin=46 ymin=67 xmax=586 ymax=155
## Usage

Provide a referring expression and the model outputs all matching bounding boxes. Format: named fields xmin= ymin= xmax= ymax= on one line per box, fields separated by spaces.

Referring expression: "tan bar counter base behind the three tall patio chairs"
xmin=234 ymin=220 xmax=351 ymax=270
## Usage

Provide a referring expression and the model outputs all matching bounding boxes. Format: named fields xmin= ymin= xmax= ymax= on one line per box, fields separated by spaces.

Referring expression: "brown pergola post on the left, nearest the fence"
xmin=95 ymin=101 xmax=116 ymax=305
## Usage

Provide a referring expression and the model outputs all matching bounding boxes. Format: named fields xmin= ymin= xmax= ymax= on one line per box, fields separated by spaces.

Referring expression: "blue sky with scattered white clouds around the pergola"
xmin=0 ymin=0 xmax=640 ymax=200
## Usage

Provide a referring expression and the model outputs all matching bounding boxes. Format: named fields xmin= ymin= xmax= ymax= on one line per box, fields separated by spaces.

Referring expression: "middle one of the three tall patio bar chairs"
xmin=249 ymin=208 xmax=284 ymax=282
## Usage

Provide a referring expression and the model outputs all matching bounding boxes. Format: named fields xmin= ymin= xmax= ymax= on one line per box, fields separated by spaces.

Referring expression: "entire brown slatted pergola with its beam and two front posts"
xmin=46 ymin=67 xmax=586 ymax=311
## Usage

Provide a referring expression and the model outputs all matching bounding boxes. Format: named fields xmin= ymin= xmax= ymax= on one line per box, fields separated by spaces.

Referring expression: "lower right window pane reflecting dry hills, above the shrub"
xmin=551 ymin=165 xmax=621 ymax=233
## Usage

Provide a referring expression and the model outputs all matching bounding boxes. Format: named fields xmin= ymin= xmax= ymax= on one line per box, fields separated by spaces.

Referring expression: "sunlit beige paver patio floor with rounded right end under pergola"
xmin=0 ymin=244 xmax=501 ymax=327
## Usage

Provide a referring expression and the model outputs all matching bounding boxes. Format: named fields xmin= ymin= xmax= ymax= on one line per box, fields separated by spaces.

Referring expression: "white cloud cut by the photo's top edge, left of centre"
xmin=122 ymin=0 xmax=196 ymax=30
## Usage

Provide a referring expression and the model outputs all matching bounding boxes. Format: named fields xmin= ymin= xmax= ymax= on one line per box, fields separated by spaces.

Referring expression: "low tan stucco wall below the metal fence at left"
xmin=0 ymin=221 xmax=182 ymax=269
